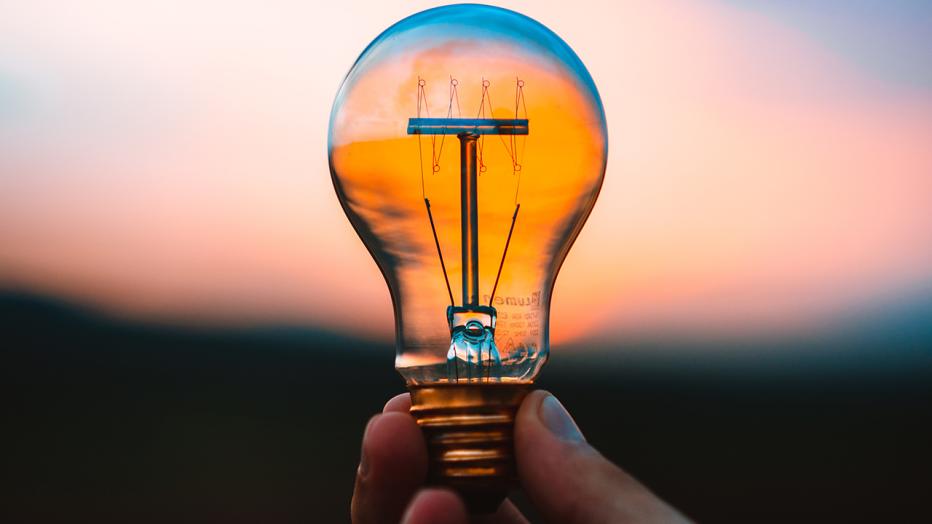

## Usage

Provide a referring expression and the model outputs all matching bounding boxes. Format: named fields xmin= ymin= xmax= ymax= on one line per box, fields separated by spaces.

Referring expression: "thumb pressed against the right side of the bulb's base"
xmin=515 ymin=391 xmax=688 ymax=524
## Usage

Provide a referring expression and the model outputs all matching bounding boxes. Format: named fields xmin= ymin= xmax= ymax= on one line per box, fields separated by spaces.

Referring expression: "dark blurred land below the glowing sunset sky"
xmin=0 ymin=292 xmax=932 ymax=522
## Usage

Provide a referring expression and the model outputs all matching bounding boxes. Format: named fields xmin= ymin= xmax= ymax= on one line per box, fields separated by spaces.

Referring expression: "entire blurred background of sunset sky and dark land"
xmin=0 ymin=0 xmax=932 ymax=524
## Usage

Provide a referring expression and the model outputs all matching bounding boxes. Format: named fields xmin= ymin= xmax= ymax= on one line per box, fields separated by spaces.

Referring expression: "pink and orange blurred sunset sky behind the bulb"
xmin=0 ymin=0 xmax=932 ymax=343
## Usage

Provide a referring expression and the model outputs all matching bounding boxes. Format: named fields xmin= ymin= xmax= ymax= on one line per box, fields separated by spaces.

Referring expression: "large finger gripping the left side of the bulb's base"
xmin=350 ymin=412 xmax=427 ymax=524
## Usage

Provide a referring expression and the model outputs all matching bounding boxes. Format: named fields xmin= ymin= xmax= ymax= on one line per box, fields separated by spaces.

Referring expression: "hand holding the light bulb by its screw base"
xmin=351 ymin=391 xmax=688 ymax=524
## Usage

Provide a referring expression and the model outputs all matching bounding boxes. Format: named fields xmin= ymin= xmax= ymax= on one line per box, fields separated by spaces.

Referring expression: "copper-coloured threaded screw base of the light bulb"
xmin=408 ymin=382 xmax=532 ymax=514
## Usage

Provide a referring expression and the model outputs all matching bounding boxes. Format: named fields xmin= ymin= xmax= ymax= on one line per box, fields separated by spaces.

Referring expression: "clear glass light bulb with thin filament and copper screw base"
xmin=329 ymin=5 xmax=607 ymax=510
